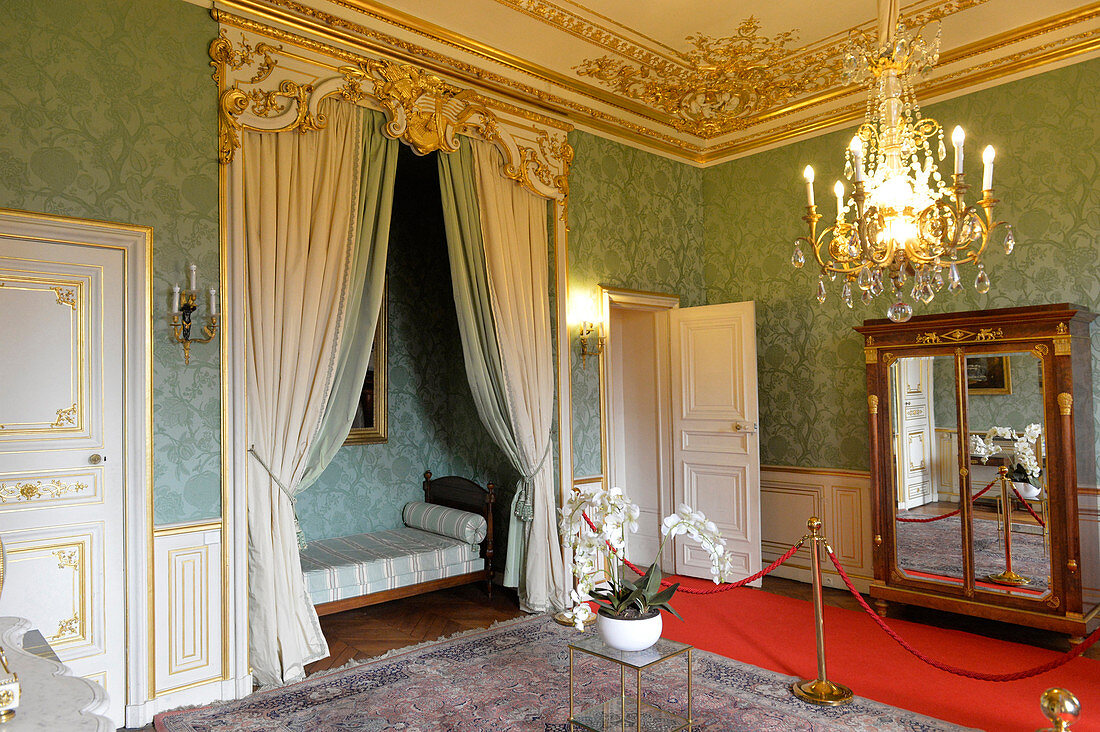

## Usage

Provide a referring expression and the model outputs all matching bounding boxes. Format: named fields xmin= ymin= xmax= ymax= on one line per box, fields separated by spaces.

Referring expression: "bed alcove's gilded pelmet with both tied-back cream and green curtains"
xmin=210 ymin=18 xmax=572 ymax=685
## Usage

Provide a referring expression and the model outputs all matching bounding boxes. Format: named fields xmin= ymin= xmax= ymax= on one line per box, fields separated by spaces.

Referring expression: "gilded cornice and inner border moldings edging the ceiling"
xmin=213 ymin=0 xmax=1098 ymax=166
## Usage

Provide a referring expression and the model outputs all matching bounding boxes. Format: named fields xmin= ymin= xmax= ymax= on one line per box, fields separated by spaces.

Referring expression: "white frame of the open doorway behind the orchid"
xmin=600 ymin=285 xmax=680 ymax=567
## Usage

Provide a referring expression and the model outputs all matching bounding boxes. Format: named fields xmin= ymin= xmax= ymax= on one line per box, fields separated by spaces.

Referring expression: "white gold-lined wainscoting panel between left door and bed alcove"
xmin=153 ymin=522 xmax=222 ymax=695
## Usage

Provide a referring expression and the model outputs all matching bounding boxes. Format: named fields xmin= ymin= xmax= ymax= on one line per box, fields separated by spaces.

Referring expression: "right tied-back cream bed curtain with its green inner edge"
xmin=440 ymin=139 xmax=568 ymax=611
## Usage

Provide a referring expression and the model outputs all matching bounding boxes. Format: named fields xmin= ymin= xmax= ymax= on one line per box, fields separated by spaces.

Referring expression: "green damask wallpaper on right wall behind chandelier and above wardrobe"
xmin=702 ymin=61 xmax=1100 ymax=477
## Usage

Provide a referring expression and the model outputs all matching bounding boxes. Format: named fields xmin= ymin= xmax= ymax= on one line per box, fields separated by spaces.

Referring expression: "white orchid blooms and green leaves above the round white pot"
xmin=561 ymin=483 xmax=733 ymax=631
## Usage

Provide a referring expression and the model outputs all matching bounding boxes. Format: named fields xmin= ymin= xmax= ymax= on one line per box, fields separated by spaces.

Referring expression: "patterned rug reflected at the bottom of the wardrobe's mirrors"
xmin=895 ymin=511 xmax=1051 ymax=592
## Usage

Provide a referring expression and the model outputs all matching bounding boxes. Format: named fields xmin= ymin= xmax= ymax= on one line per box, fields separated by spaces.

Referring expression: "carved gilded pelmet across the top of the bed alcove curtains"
xmin=210 ymin=29 xmax=573 ymax=211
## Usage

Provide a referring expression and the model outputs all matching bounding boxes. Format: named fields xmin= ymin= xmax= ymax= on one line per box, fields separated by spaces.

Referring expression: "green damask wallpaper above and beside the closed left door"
xmin=0 ymin=0 xmax=221 ymax=523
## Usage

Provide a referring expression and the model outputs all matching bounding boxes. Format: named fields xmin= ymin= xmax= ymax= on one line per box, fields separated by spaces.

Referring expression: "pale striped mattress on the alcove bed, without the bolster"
xmin=301 ymin=526 xmax=485 ymax=604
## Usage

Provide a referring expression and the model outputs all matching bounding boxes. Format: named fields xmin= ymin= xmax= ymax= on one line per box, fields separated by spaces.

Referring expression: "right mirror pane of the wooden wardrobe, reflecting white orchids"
xmin=967 ymin=351 xmax=1051 ymax=599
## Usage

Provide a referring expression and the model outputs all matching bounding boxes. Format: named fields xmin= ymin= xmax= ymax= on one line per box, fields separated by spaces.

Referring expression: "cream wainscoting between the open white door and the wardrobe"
xmin=760 ymin=466 xmax=875 ymax=592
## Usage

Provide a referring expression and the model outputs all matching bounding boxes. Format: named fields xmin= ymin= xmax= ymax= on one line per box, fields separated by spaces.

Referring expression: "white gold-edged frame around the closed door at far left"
xmin=0 ymin=209 xmax=154 ymax=708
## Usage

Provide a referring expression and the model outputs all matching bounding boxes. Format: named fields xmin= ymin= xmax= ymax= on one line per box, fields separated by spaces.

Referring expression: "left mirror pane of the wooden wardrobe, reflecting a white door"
xmin=890 ymin=354 xmax=964 ymax=586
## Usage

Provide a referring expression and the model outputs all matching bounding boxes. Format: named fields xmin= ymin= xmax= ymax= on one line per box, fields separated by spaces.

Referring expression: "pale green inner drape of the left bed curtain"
xmin=298 ymin=110 xmax=400 ymax=492
